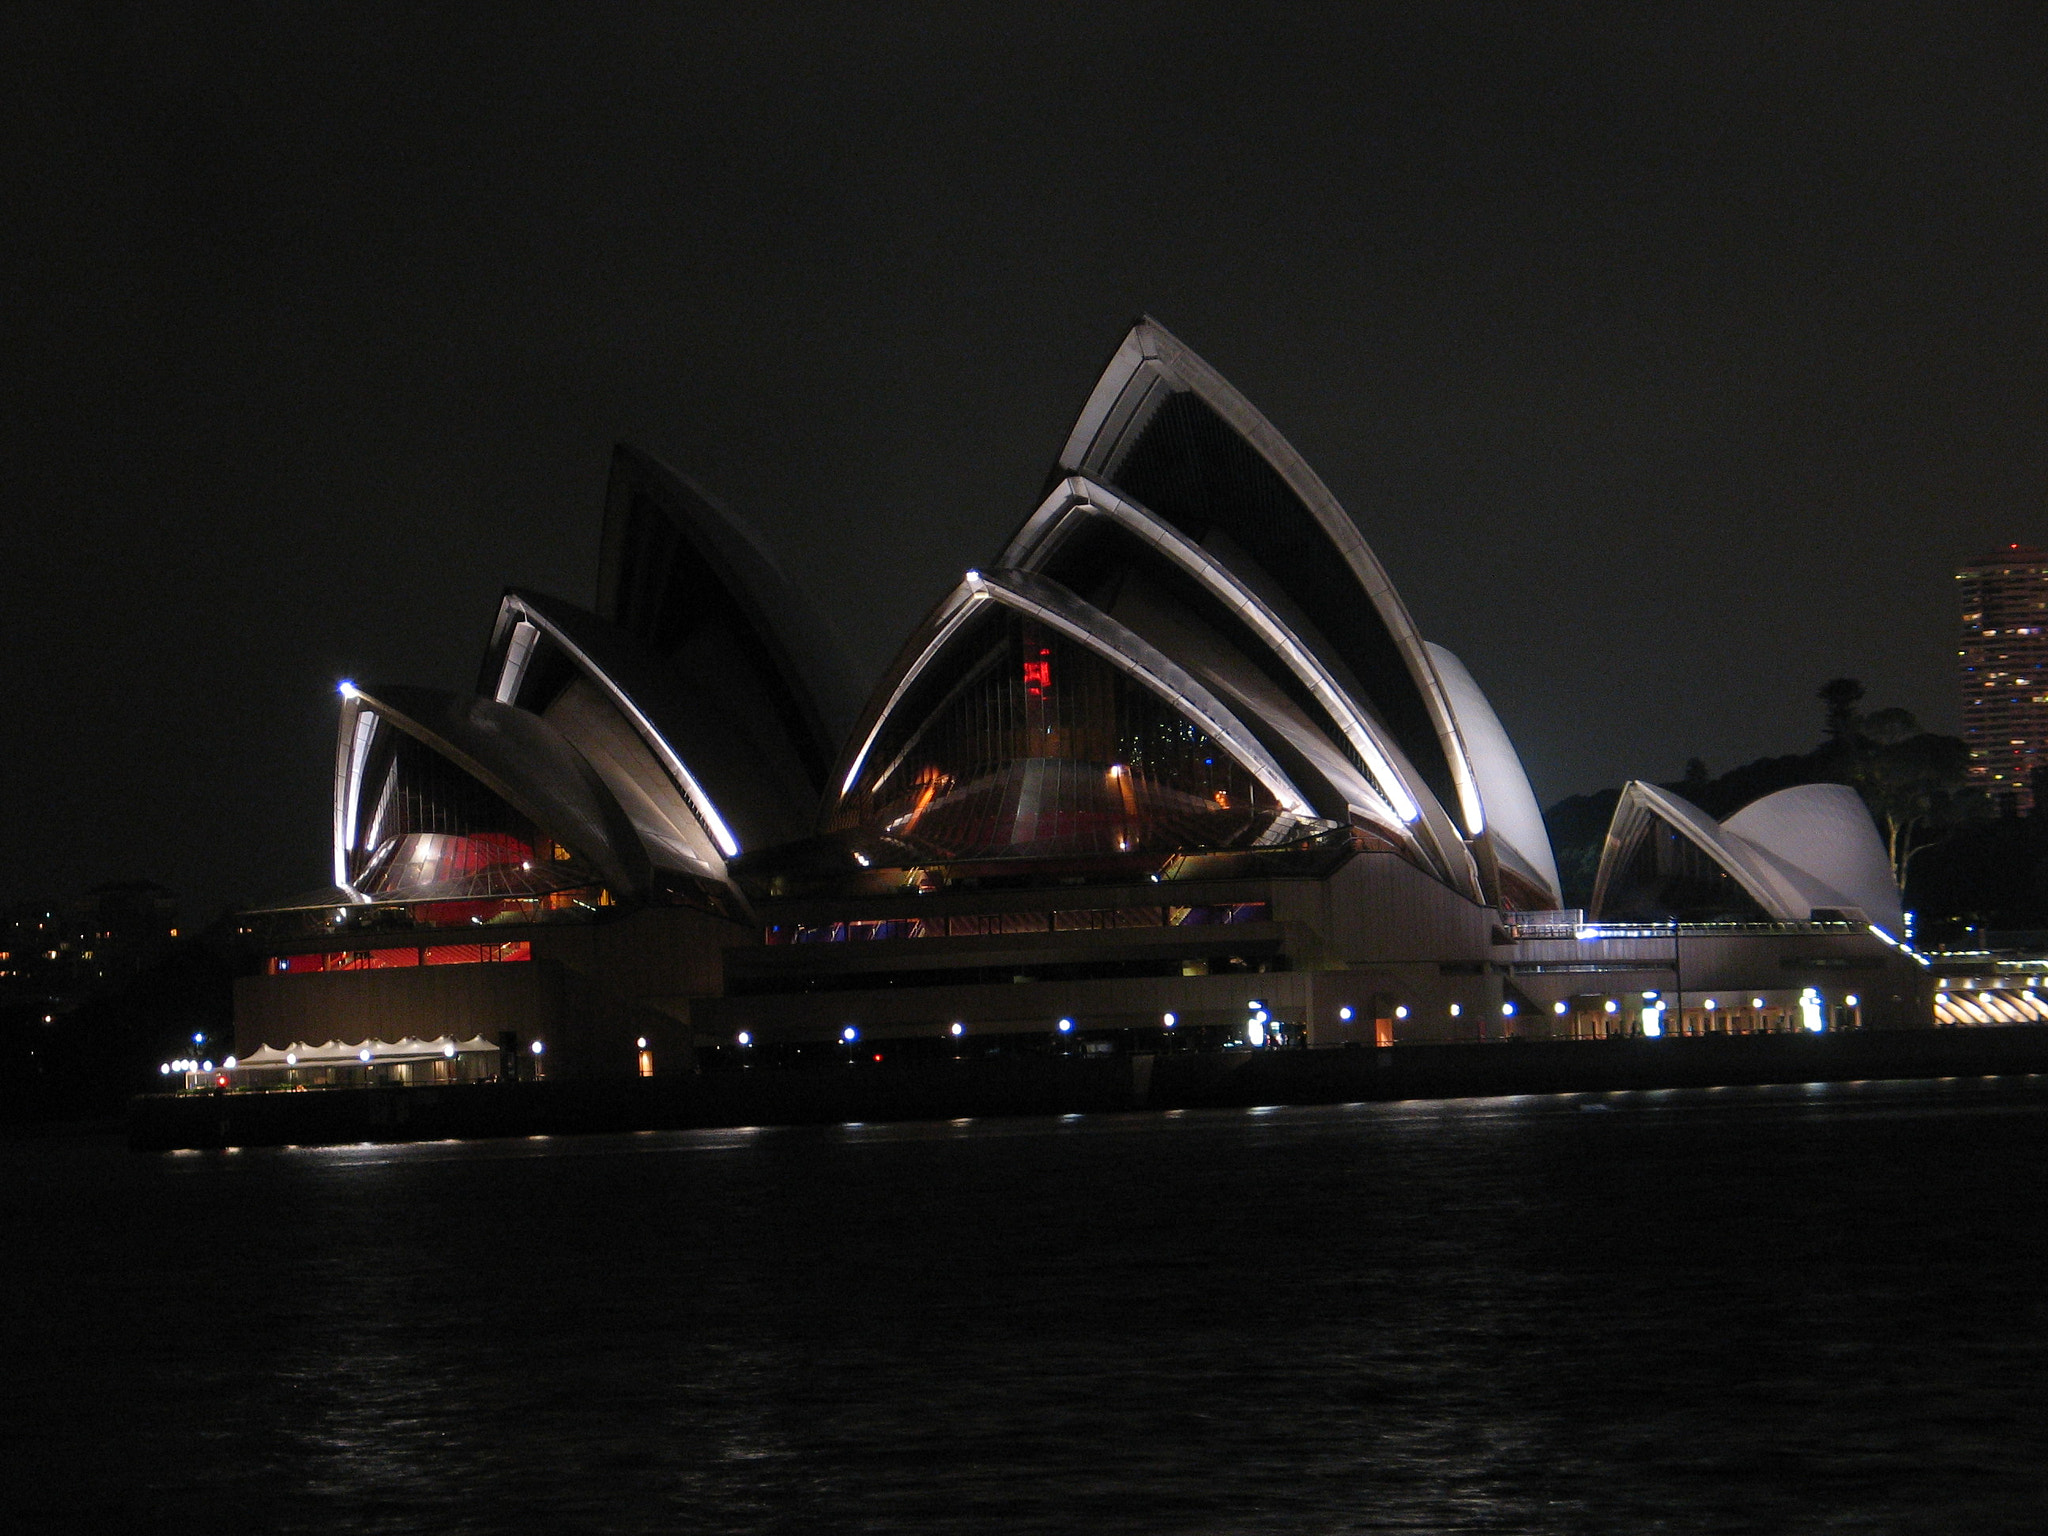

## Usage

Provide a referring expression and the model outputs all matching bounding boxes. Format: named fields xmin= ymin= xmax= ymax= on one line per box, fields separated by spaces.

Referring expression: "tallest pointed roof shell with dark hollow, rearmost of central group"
xmin=1059 ymin=317 xmax=1485 ymax=836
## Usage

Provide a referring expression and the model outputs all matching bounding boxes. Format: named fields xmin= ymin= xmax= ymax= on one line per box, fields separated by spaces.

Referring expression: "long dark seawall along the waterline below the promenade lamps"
xmin=129 ymin=1026 xmax=2048 ymax=1151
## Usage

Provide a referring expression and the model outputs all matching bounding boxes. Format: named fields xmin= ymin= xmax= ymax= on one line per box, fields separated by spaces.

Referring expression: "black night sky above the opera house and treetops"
xmin=0 ymin=0 xmax=2048 ymax=918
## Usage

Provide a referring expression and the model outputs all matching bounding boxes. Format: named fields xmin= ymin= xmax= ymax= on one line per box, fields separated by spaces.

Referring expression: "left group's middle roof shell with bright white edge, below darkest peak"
xmin=479 ymin=592 xmax=749 ymax=879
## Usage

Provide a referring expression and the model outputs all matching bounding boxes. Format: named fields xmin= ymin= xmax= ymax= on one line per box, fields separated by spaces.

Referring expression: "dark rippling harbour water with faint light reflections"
xmin=0 ymin=1079 xmax=2048 ymax=1536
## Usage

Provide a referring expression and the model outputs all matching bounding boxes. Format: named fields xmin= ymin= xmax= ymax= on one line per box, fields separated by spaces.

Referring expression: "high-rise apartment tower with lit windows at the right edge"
xmin=1956 ymin=545 xmax=2048 ymax=815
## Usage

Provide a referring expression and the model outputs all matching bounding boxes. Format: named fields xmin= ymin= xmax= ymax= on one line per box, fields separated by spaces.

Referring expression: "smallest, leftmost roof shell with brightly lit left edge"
xmin=334 ymin=684 xmax=651 ymax=901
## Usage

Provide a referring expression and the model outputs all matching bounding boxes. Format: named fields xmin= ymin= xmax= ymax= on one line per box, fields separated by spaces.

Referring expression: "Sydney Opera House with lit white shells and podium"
xmin=220 ymin=322 xmax=1929 ymax=1085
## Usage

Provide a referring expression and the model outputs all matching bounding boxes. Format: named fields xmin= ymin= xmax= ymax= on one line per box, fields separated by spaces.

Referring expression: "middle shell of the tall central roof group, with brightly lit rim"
xmin=1004 ymin=475 xmax=1473 ymax=885
